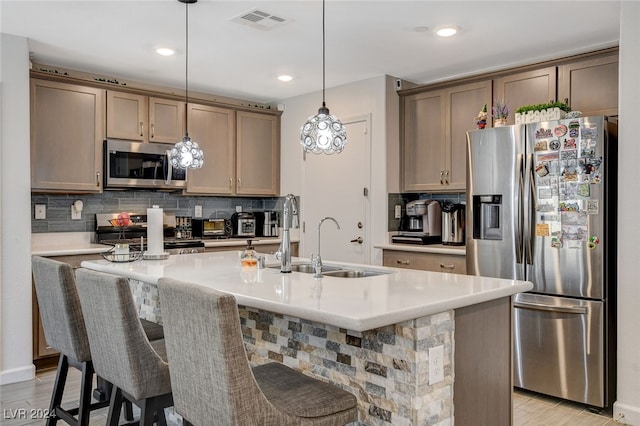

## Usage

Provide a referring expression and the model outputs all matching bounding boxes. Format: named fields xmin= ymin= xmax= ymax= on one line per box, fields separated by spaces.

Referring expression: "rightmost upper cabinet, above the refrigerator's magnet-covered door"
xmin=558 ymin=53 xmax=618 ymax=116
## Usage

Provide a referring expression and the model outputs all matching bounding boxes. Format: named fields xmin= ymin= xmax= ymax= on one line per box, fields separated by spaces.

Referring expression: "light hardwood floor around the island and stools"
xmin=0 ymin=369 xmax=622 ymax=426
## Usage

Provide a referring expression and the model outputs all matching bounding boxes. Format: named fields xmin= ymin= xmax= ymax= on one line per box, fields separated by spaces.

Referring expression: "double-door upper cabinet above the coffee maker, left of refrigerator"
xmin=400 ymin=80 xmax=491 ymax=192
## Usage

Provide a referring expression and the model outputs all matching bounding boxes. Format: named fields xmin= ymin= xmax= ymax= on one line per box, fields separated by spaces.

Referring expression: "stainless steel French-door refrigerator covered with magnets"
xmin=466 ymin=117 xmax=617 ymax=408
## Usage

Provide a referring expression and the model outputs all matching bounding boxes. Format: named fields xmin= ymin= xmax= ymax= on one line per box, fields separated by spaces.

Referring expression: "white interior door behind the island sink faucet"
xmin=300 ymin=116 xmax=371 ymax=264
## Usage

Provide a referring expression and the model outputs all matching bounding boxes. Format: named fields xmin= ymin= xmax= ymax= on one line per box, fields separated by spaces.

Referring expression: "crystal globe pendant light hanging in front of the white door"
xmin=300 ymin=0 xmax=347 ymax=154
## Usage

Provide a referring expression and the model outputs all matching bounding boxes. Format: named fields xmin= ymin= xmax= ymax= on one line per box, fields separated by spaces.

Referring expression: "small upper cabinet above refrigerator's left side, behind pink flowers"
xmin=488 ymin=66 xmax=557 ymax=124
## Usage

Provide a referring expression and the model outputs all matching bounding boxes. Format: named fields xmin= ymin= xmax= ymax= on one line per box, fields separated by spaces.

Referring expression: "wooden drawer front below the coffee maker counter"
xmin=382 ymin=250 xmax=467 ymax=275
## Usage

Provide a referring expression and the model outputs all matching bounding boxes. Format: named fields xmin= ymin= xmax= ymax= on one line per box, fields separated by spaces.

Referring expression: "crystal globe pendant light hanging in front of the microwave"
xmin=171 ymin=0 xmax=204 ymax=170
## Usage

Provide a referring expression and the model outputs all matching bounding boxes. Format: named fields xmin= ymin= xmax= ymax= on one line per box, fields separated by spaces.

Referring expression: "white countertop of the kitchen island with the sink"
xmin=82 ymin=248 xmax=533 ymax=331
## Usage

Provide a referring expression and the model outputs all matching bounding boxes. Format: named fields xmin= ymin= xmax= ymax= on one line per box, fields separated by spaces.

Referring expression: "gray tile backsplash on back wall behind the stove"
xmin=31 ymin=191 xmax=284 ymax=233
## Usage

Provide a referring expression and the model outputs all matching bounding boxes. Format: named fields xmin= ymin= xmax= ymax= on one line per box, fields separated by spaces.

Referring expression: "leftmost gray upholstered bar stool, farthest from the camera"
xmin=31 ymin=256 xmax=164 ymax=425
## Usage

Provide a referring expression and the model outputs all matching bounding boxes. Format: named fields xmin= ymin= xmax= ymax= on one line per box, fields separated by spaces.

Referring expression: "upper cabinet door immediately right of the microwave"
xmin=185 ymin=104 xmax=236 ymax=195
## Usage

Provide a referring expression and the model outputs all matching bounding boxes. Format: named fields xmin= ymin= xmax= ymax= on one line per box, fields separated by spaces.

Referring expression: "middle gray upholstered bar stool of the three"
xmin=76 ymin=268 xmax=173 ymax=426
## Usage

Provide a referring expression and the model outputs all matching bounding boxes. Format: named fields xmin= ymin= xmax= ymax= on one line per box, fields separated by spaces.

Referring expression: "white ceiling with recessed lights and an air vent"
xmin=0 ymin=0 xmax=620 ymax=103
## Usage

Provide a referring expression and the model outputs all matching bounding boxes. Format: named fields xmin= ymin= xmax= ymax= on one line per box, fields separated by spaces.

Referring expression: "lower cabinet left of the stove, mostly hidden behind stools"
xmin=32 ymin=254 xmax=102 ymax=370
